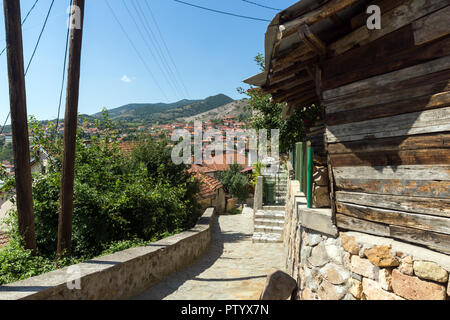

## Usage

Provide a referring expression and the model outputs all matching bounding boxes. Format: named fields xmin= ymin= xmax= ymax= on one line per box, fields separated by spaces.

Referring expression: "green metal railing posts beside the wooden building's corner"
xmin=290 ymin=141 xmax=314 ymax=208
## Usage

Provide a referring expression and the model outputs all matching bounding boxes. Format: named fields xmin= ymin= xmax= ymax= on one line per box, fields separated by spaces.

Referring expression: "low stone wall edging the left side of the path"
xmin=0 ymin=208 xmax=214 ymax=300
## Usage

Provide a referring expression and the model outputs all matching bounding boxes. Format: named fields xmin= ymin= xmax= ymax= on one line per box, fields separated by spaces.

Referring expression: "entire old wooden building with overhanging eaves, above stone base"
xmin=245 ymin=0 xmax=450 ymax=254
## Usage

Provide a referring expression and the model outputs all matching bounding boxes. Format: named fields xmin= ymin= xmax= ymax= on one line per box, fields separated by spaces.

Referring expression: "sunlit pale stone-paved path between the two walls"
xmin=135 ymin=208 xmax=285 ymax=300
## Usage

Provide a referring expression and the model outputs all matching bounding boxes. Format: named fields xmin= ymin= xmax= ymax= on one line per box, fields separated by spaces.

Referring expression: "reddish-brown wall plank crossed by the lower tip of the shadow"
xmin=331 ymin=148 xmax=450 ymax=167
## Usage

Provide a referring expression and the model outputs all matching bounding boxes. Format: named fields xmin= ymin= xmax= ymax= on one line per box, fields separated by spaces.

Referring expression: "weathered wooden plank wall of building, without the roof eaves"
xmin=321 ymin=0 xmax=450 ymax=254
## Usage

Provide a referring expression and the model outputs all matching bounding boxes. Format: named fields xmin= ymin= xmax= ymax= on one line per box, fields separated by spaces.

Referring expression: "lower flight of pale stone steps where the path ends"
xmin=252 ymin=206 xmax=284 ymax=243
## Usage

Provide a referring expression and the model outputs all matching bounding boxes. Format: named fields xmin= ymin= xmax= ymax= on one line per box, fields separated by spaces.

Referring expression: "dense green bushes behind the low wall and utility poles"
xmin=0 ymin=111 xmax=201 ymax=281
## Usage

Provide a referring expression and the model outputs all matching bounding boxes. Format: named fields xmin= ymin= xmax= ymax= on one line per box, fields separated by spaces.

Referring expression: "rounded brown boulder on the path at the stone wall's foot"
xmin=260 ymin=269 xmax=297 ymax=300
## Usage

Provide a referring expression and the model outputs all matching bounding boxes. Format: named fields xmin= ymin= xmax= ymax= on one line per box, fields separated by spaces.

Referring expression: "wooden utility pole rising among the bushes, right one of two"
xmin=57 ymin=0 xmax=84 ymax=257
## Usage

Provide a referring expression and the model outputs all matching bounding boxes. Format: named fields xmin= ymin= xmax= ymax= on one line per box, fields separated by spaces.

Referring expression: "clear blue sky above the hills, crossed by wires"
xmin=0 ymin=0 xmax=297 ymax=124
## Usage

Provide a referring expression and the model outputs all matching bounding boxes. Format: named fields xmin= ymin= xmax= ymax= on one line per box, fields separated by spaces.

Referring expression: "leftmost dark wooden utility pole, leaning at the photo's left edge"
xmin=3 ymin=0 xmax=36 ymax=253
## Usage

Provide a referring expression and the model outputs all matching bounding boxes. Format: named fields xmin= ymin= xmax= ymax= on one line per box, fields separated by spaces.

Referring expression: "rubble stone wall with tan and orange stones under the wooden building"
xmin=284 ymin=180 xmax=450 ymax=300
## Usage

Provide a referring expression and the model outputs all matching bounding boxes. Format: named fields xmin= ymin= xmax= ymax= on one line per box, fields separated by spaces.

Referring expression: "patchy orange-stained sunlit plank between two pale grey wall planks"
xmin=335 ymin=179 xmax=450 ymax=199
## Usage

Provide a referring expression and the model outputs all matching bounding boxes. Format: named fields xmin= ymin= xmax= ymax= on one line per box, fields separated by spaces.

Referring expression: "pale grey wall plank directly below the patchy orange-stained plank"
xmin=336 ymin=191 xmax=450 ymax=218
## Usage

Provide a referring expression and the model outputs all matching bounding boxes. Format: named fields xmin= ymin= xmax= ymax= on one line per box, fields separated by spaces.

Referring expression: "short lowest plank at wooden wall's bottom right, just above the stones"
xmin=389 ymin=226 xmax=450 ymax=254
